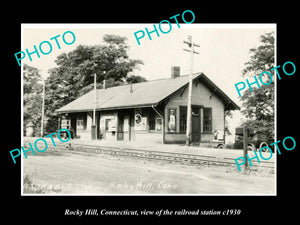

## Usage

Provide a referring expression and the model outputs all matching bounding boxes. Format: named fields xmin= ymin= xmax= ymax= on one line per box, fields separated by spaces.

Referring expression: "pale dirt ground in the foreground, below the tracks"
xmin=23 ymin=150 xmax=276 ymax=195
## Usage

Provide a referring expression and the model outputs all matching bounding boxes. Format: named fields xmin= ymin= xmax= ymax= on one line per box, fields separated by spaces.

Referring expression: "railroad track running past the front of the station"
xmin=24 ymin=141 xmax=274 ymax=168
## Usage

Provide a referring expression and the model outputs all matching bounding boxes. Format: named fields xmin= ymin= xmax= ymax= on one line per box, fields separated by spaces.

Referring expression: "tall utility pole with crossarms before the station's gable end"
xmin=183 ymin=35 xmax=200 ymax=145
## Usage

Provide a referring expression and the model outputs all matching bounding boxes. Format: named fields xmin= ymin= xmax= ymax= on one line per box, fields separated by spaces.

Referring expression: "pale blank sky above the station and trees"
xmin=21 ymin=23 xmax=276 ymax=142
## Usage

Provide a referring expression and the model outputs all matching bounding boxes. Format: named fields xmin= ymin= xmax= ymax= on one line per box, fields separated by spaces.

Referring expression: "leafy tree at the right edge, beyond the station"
xmin=241 ymin=32 xmax=274 ymax=136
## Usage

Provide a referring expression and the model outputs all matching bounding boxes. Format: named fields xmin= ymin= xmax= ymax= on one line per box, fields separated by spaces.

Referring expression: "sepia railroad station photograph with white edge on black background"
xmin=21 ymin=22 xmax=276 ymax=196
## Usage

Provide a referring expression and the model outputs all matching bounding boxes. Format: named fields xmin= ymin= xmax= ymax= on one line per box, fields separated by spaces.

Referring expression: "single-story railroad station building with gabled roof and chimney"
xmin=56 ymin=67 xmax=240 ymax=144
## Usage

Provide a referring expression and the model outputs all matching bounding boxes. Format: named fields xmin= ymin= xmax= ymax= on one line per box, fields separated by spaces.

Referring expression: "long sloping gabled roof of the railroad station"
xmin=56 ymin=73 xmax=240 ymax=113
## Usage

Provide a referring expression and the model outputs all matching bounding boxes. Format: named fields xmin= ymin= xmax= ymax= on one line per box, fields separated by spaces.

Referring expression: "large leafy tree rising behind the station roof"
xmin=45 ymin=35 xmax=143 ymax=132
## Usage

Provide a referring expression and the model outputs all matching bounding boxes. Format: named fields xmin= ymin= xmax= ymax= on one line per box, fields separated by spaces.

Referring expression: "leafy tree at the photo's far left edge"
xmin=23 ymin=63 xmax=42 ymax=136
